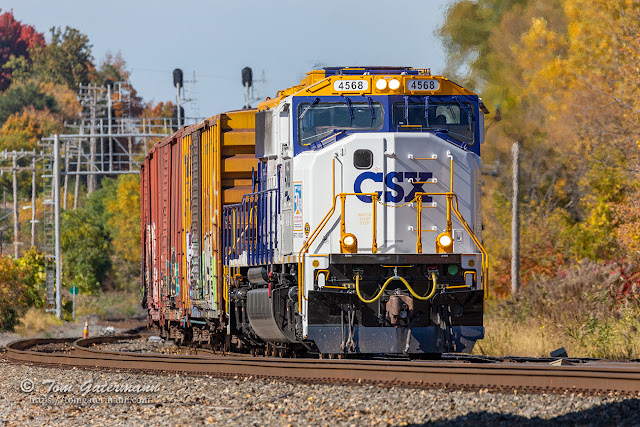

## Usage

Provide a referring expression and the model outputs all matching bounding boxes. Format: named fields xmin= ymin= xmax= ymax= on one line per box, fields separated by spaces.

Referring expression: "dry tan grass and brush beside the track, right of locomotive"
xmin=474 ymin=262 xmax=640 ymax=359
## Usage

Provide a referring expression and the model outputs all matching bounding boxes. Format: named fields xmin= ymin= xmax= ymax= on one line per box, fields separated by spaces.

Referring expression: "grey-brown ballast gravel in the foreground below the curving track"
xmin=0 ymin=360 xmax=640 ymax=426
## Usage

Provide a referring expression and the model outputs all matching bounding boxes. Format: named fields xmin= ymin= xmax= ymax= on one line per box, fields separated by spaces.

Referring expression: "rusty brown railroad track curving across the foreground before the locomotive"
xmin=6 ymin=335 xmax=640 ymax=394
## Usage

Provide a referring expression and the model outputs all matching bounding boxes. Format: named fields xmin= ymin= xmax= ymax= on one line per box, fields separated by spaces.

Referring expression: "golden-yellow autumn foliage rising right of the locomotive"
xmin=440 ymin=0 xmax=640 ymax=294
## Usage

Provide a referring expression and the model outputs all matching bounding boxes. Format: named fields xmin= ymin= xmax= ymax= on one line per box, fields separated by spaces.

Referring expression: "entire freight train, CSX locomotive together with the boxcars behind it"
xmin=140 ymin=67 xmax=488 ymax=357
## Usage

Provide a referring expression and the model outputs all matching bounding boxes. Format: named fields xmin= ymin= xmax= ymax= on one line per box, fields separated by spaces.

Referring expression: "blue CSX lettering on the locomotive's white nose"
xmin=353 ymin=172 xmax=433 ymax=203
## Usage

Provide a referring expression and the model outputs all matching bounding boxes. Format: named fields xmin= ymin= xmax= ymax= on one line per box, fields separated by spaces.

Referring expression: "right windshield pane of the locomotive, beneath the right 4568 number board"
xmin=393 ymin=101 xmax=475 ymax=145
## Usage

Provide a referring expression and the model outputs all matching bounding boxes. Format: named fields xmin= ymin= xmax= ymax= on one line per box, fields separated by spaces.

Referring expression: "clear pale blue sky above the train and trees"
xmin=7 ymin=0 xmax=451 ymax=122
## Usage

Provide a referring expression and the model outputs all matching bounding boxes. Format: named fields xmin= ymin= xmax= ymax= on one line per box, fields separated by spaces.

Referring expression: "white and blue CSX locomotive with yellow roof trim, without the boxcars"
xmin=222 ymin=67 xmax=488 ymax=356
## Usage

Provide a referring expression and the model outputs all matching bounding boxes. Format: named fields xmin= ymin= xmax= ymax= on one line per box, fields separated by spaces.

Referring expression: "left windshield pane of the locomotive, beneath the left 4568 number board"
xmin=298 ymin=98 xmax=384 ymax=145
